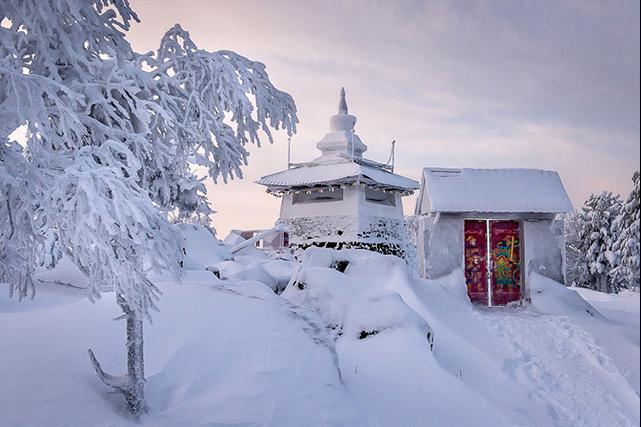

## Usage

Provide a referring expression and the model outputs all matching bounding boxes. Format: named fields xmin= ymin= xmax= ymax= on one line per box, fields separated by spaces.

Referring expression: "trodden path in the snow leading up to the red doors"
xmin=479 ymin=307 xmax=638 ymax=426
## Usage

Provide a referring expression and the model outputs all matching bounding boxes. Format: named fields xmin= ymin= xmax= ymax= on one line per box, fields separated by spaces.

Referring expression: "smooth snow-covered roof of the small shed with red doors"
xmin=416 ymin=168 xmax=574 ymax=214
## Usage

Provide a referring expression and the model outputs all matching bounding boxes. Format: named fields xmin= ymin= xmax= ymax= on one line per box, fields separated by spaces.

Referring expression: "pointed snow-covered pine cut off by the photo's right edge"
xmin=611 ymin=171 xmax=640 ymax=289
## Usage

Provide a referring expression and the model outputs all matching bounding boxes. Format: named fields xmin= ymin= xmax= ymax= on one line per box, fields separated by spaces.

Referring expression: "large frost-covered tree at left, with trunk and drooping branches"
xmin=0 ymin=0 xmax=297 ymax=414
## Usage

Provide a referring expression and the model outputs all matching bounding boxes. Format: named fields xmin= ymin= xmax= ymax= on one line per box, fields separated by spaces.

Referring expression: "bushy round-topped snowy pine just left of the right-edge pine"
xmin=577 ymin=191 xmax=621 ymax=293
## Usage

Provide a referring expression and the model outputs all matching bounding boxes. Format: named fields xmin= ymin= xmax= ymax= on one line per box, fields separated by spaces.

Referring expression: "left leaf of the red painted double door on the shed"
xmin=465 ymin=220 xmax=488 ymax=305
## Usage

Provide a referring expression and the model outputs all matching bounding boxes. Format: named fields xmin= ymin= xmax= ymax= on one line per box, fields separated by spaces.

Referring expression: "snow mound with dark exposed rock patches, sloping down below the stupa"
xmin=283 ymin=248 xmax=510 ymax=426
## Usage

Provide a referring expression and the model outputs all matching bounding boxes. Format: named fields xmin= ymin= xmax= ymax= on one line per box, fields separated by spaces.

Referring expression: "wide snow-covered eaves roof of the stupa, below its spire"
xmin=257 ymin=160 xmax=419 ymax=190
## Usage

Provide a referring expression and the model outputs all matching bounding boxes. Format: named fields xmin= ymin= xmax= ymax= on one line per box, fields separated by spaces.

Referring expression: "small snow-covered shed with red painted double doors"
xmin=415 ymin=168 xmax=573 ymax=306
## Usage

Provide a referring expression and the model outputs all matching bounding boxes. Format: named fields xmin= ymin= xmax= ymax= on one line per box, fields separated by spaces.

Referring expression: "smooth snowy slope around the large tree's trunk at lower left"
xmin=0 ymin=272 xmax=354 ymax=426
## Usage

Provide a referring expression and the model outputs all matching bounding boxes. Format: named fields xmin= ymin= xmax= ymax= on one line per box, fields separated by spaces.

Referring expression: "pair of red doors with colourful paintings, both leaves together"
xmin=465 ymin=220 xmax=521 ymax=305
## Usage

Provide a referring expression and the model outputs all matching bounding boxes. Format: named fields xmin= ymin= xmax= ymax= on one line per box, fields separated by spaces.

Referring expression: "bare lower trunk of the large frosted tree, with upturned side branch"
xmin=89 ymin=295 xmax=147 ymax=415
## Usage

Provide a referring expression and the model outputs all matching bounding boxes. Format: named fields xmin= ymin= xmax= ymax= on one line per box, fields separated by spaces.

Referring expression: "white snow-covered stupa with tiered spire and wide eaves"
xmin=258 ymin=89 xmax=419 ymax=255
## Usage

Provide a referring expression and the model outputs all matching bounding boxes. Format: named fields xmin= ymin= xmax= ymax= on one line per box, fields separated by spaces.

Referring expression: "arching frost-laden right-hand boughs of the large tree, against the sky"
xmin=152 ymin=25 xmax=298 ymax=182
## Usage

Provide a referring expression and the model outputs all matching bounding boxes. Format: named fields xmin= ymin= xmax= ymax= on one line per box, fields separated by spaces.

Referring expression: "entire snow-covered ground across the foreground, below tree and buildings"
xmin=0 ymin=231 xmax=640 ymax=426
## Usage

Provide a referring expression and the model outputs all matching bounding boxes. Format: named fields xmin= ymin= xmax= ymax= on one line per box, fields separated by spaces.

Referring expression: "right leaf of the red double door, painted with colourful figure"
xmin=489 ymin=221 xmax=521 ymax=305
